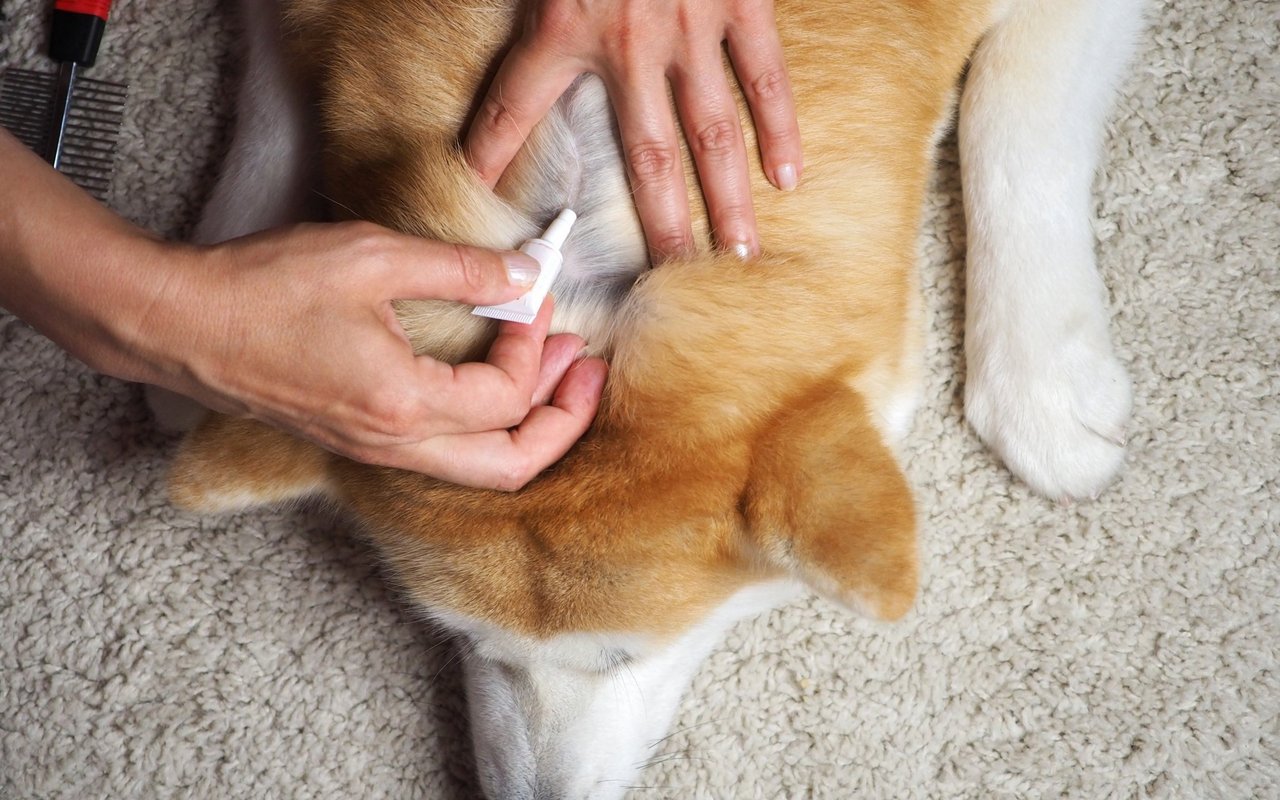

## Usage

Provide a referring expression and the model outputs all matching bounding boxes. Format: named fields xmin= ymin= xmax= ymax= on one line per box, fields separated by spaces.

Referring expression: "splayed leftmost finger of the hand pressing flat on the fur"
xmin=462 ymin=40 xmax=581 ymax=188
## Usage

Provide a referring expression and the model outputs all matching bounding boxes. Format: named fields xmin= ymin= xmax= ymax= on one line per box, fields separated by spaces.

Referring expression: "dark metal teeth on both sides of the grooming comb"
xmin=0 ymin=69 xmax=125 ymax=202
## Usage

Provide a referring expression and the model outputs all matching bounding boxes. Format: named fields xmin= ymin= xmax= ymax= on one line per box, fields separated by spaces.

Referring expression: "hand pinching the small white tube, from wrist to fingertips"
xmin=148 ymin=223 xmax=605 ymax=490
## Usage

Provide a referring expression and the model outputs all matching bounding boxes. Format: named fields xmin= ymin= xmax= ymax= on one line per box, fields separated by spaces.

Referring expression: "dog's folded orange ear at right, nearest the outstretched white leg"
xmin=744 ymin=384 xmax=919 ymax=620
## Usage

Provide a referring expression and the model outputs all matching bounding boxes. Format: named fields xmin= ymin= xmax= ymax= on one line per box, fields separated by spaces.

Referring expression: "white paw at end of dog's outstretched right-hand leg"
xmin=965 ymin=317 xmax=1133 ymax=502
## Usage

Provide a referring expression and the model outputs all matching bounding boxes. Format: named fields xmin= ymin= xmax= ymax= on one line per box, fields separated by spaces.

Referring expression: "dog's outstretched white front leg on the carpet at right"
xmin=960 ymin=0 xmax=1142 ymax=499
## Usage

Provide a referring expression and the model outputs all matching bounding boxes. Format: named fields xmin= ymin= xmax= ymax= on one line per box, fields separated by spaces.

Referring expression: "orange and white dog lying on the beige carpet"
xmin=160 ymin=0 xmax=1140 ymax=800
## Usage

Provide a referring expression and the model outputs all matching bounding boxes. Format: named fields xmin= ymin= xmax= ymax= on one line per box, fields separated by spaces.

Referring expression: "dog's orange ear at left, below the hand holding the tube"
xmin=169 ymin=413 xmax=332 ymax=512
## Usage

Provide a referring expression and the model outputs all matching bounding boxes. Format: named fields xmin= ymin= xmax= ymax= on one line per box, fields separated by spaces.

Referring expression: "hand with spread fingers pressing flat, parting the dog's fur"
xmin=465 ymin=0 xmax=801 ymax=260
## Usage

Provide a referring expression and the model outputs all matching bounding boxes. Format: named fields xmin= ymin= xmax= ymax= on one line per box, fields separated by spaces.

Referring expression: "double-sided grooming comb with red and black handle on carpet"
xmin=0 ymin=0 xmax=125 ymax=202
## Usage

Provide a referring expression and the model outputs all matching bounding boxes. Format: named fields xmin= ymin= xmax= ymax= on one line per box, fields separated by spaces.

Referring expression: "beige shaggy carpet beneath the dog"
xmin=0 ymin=0 xmax=1280 ymax=800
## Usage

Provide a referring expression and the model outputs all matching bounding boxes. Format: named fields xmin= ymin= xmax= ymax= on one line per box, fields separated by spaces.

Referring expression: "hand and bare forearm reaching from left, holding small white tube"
xmin=0 ymin=129 xmax=607 ymax=489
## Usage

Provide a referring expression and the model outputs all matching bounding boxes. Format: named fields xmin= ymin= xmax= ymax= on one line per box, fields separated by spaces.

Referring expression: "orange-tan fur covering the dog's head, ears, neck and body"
xmin=172 ymin=0 xmax=991 ymax=636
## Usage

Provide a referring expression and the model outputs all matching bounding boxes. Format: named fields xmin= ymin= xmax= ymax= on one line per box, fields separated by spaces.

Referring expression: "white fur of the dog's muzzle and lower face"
xmin=436 ymin=581 xmax=801 ymax=800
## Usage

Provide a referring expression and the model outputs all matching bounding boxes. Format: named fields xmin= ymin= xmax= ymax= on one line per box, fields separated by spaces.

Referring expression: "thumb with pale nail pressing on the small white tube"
xmin=393 ymin=237 xmax=541 ymax=306
